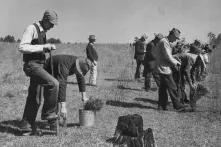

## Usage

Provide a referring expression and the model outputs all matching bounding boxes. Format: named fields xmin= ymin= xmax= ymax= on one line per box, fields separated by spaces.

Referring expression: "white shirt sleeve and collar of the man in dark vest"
xmin=18 ymin=22 xmax=44 ymax=54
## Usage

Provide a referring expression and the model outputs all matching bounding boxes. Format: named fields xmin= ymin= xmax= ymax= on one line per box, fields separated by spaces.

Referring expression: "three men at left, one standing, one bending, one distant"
xmin=19 ymin=10 xmax=98 ymax=132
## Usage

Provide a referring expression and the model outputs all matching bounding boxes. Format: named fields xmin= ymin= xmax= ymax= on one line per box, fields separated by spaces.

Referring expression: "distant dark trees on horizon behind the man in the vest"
xmin=0 ymin=35 xmax=62 ymax=44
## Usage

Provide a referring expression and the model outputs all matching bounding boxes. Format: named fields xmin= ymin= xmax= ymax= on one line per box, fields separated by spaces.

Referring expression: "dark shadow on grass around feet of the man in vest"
xmin=0 ymin=120 xmax=55 ymax=136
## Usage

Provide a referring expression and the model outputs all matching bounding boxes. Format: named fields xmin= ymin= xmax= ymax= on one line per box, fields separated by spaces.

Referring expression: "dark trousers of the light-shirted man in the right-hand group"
xmin=158 ymin=74 xmax=183 ymax=109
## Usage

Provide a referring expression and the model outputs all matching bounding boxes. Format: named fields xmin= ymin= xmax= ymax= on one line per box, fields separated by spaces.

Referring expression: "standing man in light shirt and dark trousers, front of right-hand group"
xmin=156 ymin=28 xmax=185 ymax=111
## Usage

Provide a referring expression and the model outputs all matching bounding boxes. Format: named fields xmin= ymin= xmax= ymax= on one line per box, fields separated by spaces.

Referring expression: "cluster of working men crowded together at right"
xmin=133 ymin=28 xmax=211 ymax=112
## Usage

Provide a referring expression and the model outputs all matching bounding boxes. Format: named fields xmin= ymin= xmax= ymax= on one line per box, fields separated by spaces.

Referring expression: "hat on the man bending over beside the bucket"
xmin=76 ymin=57 xmax=92 ymax=76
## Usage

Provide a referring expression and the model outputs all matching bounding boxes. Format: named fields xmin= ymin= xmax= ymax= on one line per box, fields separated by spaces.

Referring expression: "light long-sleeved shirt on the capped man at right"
xmin=156 ymin=38 xmax=179 ymax=74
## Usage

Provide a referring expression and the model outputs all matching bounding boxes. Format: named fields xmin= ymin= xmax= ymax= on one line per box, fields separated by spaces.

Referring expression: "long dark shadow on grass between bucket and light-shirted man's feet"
xmin=106 ymin=100 xmax=156 ymax=109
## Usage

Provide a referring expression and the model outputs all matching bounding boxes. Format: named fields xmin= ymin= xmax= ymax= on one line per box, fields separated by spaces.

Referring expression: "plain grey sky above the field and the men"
xmin=0 ymin=0 xmax=221 ymax=43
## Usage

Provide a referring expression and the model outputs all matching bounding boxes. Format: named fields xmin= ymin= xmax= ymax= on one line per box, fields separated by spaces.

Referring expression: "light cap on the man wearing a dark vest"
xmin=42 ymin=10 xmax=58 ymax=25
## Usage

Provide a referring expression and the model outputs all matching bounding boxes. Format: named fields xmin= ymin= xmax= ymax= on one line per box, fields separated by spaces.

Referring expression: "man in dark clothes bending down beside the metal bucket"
xmin=45 ymin=55 xmax=92 ymax=119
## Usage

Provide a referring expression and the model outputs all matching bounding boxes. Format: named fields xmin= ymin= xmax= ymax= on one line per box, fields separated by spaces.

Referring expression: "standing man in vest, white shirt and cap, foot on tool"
xmin=19 ymin=10 xmax=59 ymax=132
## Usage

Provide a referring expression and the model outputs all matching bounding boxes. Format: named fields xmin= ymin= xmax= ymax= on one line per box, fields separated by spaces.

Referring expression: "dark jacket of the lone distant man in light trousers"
xmin=86 ymin=43 xmax=98 ymax=62
